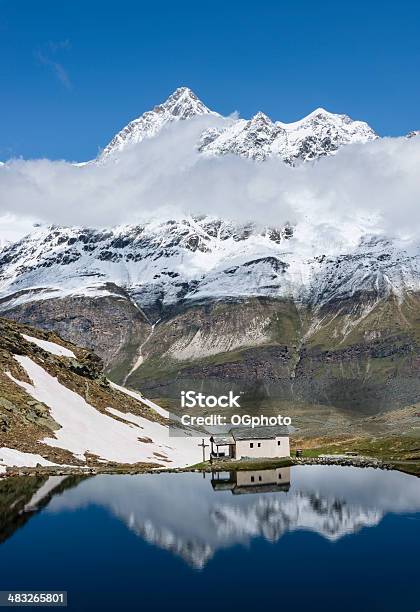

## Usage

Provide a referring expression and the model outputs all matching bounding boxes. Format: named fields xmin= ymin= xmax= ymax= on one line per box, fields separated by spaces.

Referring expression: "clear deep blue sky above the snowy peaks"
xmin=0 ymin=0 xmax=420 ymax=160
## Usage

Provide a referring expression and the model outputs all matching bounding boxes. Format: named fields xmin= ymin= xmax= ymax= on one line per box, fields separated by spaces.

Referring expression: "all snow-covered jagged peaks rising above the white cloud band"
xmin=99 ymin=87 xmax=377 ymax=165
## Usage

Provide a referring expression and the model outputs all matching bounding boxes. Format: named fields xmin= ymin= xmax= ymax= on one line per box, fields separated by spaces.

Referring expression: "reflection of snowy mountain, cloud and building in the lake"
xmin=0 ymin=466 xmax=420 ymax=569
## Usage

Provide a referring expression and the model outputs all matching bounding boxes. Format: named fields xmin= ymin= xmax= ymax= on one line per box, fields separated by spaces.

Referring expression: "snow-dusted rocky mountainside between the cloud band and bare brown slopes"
xmin=0 ymin=217 xmax=420 ymax=318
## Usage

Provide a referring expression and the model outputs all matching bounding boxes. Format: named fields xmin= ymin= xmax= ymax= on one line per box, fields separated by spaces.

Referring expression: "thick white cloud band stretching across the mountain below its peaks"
xmin=0 ymin=117 xmax=420 ymax=245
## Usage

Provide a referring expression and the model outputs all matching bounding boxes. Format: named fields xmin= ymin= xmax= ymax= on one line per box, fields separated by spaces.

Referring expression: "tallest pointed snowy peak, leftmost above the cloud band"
xmin=99 ymin=87 xmax=218 ymax=160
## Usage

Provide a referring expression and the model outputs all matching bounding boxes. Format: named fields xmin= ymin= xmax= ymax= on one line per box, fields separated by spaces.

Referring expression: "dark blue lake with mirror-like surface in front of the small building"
xmin=0 ymin=466 xmax=420 ymax=612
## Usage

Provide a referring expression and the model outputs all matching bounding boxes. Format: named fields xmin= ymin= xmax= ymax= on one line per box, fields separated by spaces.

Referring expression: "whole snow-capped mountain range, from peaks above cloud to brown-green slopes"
xmin=0 ymin=88 xmax=420 ymax=415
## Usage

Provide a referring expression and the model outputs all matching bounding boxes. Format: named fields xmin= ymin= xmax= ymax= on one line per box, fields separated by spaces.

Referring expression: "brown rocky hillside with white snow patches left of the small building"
xmin=0 ymin=319 xmax=200 ymax=473
